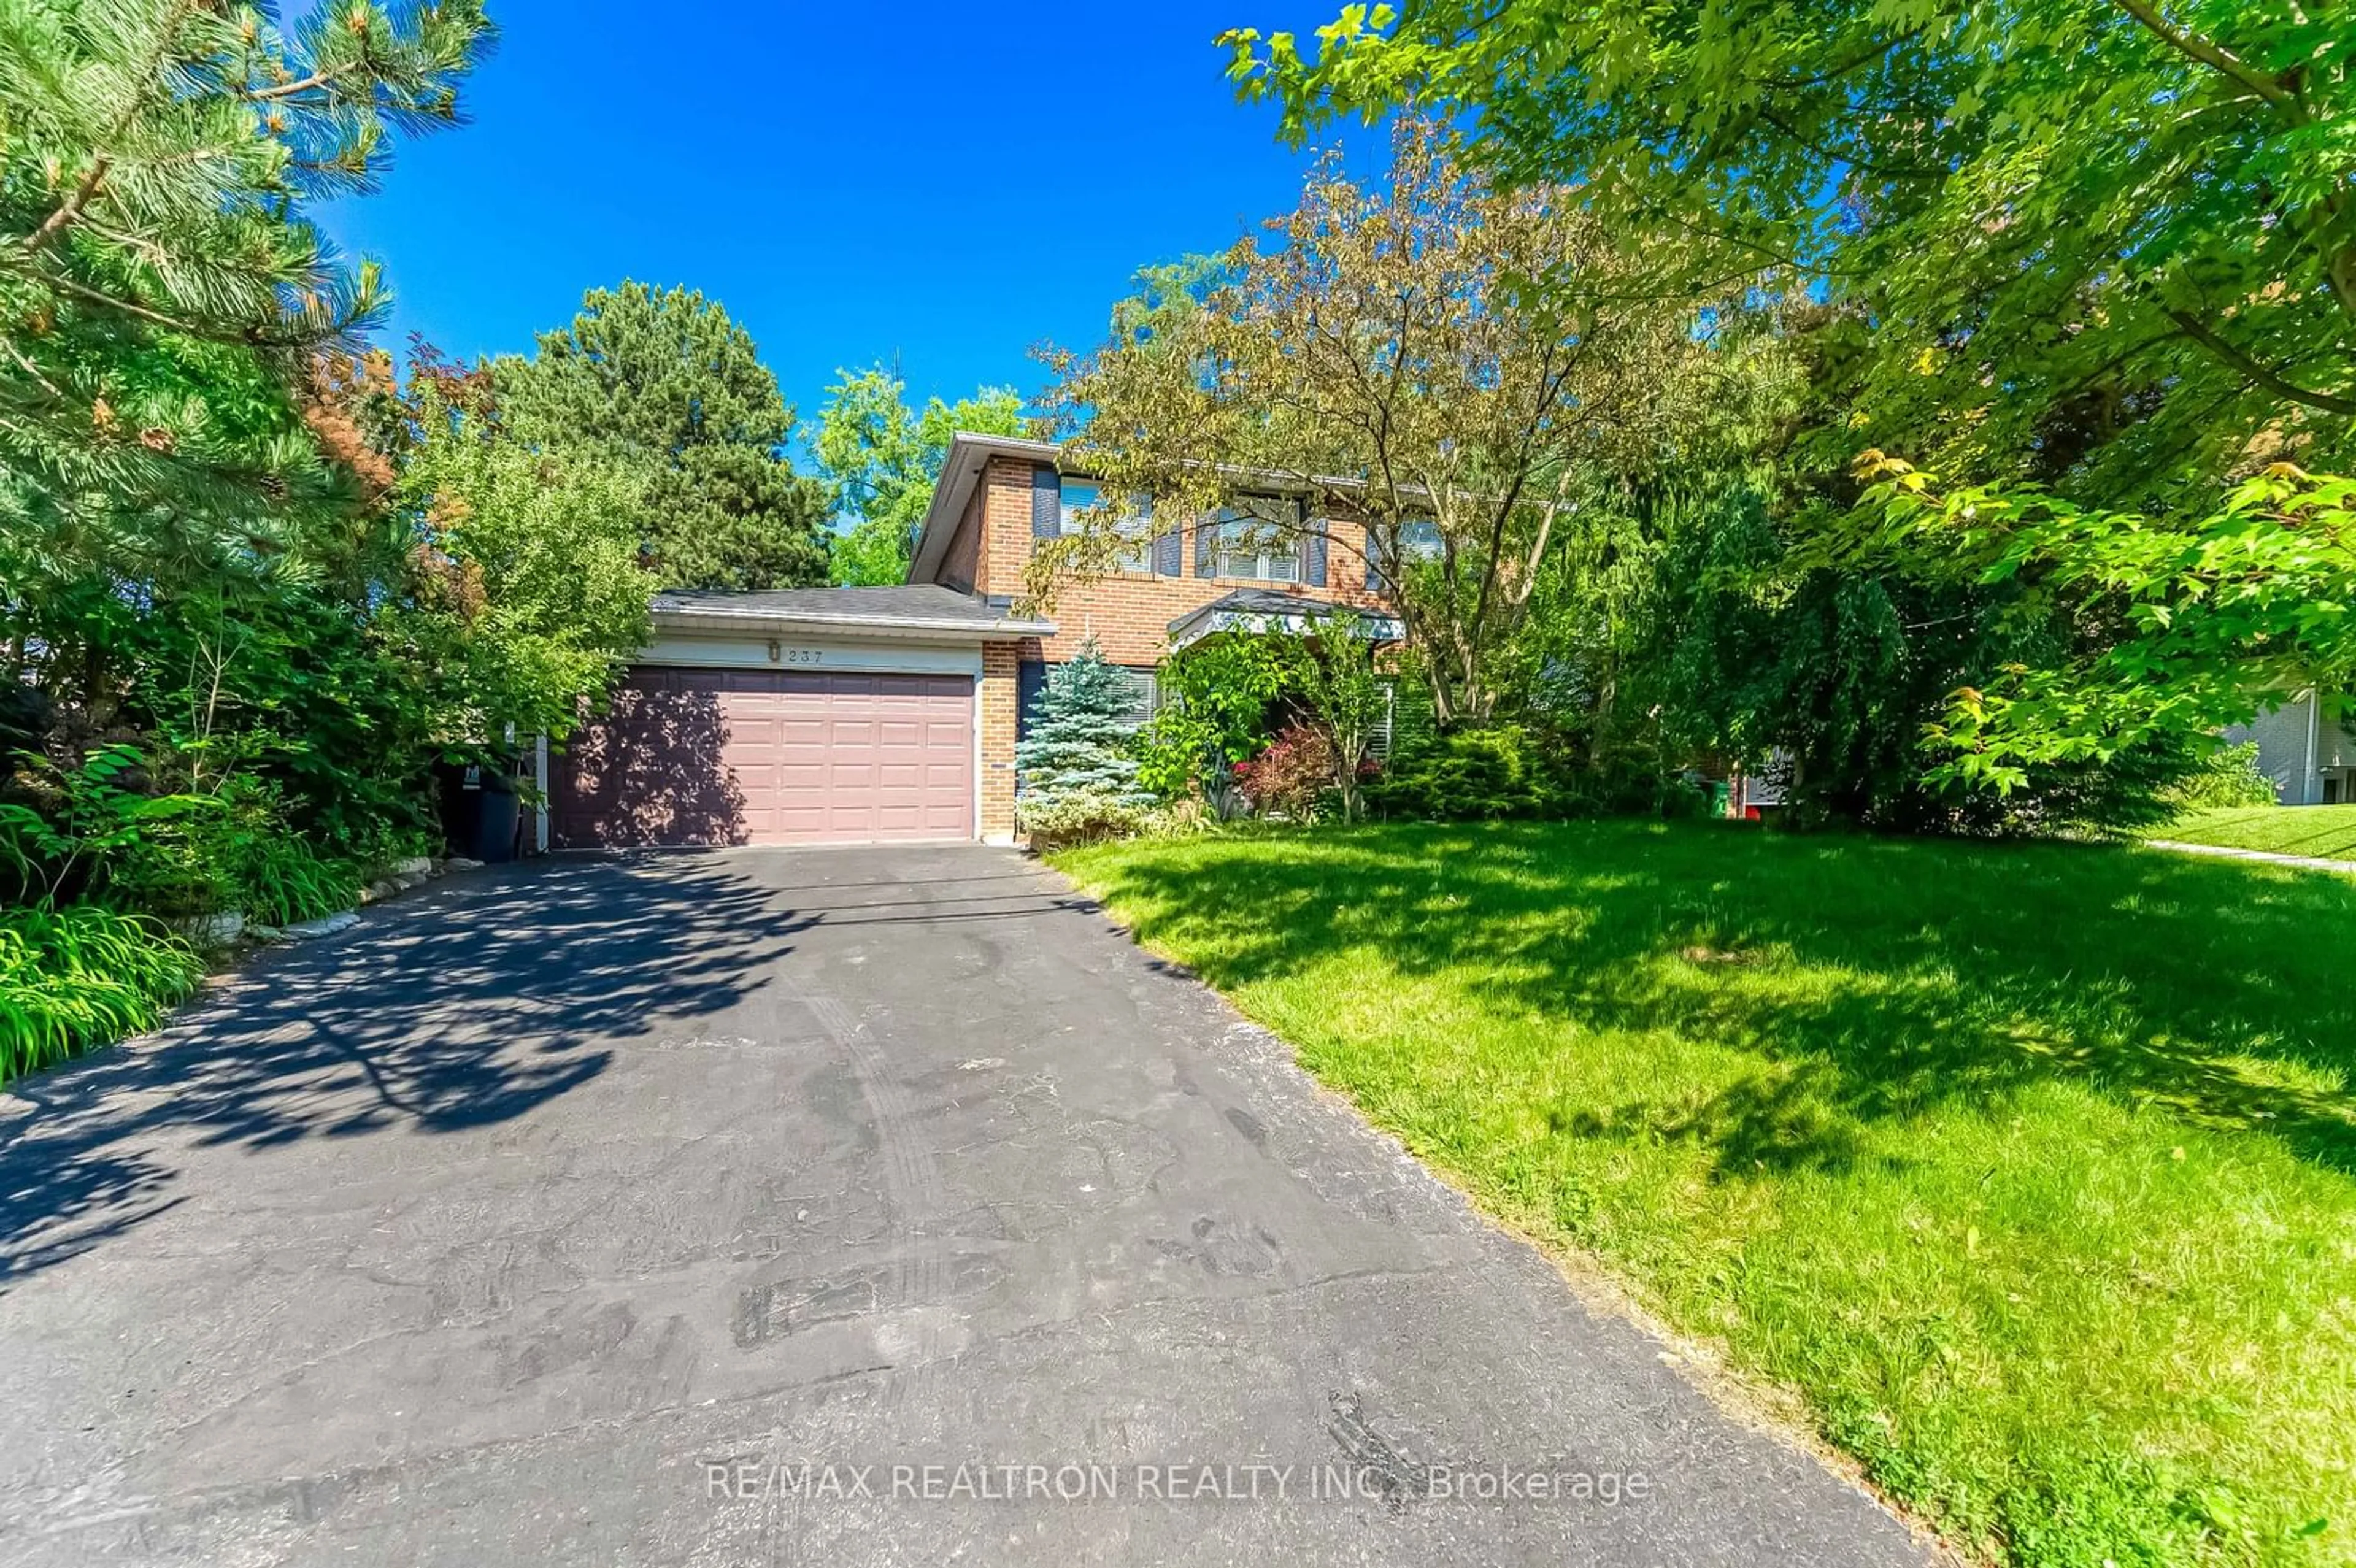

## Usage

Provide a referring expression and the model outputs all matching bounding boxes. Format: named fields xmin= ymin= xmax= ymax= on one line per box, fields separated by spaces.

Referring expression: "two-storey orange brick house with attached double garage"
xmin=539 ymin=436 xmax=1397 ymax=848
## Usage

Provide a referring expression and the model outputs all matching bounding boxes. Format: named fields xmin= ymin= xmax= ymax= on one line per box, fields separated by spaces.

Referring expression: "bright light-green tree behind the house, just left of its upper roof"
xmin=815 ymin=365 xmax=1030 ymax=586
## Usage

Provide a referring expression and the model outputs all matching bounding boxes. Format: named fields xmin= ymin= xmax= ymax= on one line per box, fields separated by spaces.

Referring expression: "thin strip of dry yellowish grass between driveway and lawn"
xmin=1050 ymin=852 xmax=1969 ymax=1568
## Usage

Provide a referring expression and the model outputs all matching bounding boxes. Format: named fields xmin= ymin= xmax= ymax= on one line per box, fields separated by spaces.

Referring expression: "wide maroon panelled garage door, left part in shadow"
xmin=549 ymin=666 xmax=973 ymax=850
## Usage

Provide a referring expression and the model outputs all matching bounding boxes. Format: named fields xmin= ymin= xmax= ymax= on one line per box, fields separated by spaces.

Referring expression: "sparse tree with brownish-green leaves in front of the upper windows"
xmin=1027 ymin=118 xmax=1795 ymax=725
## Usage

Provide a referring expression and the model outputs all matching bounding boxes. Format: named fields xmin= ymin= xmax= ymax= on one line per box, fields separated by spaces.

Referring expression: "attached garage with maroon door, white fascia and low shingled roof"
xmin=549 ymin=584 xmax=1039 ymax=850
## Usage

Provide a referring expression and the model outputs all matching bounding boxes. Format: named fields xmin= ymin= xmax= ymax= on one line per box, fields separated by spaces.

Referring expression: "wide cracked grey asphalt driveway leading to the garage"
xmin=0 ymin=845 xmax=1925 ymax=1568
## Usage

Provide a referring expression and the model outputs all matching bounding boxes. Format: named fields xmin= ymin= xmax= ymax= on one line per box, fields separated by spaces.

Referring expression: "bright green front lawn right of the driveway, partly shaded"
xmin=1055 ymin=824 xmax=2356 ymax=1568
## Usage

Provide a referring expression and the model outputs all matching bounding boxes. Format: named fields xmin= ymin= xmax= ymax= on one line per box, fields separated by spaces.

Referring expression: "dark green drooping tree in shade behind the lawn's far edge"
xmin=1529 ymin=473 xmax=2208 ymax=834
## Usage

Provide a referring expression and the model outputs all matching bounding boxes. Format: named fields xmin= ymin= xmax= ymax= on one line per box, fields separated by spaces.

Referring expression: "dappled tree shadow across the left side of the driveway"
xmin=0 ymin=855 xmax=808 ymax=1293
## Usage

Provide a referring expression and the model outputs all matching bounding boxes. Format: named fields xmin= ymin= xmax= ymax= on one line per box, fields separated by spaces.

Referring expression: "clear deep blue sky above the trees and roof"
xmin=325 ymin=0 xmax=1369 ymax=419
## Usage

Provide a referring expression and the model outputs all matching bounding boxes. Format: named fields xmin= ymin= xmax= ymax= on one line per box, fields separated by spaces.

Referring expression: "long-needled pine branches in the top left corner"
xmin=0 ymin=0 xmax=490 ymax=532
